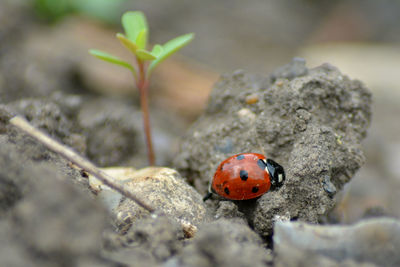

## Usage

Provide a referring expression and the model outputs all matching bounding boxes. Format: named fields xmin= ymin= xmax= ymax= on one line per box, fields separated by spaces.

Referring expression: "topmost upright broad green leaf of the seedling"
xmin=121 ymin=11 xmax=149 ymax=43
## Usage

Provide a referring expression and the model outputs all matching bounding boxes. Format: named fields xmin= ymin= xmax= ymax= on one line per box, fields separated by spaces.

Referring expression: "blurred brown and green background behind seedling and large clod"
xmin=0 ymin=0 xmax=400 ymax=223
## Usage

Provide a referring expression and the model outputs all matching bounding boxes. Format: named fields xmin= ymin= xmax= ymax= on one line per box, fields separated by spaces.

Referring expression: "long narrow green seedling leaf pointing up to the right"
xmin=147 ymin=33 xmax=194 ymax=76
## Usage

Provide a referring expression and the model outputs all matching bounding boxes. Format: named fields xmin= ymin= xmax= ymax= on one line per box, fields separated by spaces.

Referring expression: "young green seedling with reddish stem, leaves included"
xmin=89 ymin=11 xmax=194 ymax=165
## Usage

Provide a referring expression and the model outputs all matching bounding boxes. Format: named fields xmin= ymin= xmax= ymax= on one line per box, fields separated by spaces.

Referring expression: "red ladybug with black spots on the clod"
xmin=203 ymin=153 xmax=285 ymax=201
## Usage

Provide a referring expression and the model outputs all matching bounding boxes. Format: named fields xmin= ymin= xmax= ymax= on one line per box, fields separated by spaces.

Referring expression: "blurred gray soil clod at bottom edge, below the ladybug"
xmin=164 ymin=219 xmax=272 ymax=267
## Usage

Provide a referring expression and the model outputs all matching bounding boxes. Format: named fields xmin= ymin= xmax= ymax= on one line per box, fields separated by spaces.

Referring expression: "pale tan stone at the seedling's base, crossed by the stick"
xmin=114 ymin=167 xmax=209 ymax=229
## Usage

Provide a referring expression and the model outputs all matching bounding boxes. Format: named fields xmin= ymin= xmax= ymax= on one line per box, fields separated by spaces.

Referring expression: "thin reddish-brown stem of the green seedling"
xmin=137 ymin=60 xmax=155 ymax=166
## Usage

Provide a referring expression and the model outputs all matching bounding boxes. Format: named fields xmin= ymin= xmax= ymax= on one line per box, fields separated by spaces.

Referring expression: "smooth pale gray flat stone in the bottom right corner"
xmin=273 ymin=218 xmax=400 ymax=266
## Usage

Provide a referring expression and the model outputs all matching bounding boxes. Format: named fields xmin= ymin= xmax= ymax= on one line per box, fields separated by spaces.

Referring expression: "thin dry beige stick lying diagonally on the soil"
xmin=10 ymin=116 xmax=155 ymax=213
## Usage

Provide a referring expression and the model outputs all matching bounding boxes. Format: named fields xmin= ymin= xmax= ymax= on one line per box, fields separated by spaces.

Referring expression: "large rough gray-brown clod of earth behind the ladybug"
xmin=174 ymin=59 xmax=371 ymax=236
